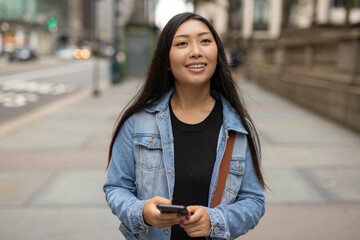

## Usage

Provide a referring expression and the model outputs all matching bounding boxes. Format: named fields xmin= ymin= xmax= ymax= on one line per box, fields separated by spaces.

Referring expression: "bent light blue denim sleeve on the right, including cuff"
xmin=207 ymin=143 xmax=265 ymax=240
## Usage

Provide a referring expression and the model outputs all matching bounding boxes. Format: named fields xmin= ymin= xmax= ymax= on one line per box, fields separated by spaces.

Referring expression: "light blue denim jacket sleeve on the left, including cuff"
xmin=103 ymin=118 xmax=148 ymax=234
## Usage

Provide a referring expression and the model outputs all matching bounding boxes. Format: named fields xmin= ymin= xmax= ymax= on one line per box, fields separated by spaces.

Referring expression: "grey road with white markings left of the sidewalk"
xmin=0 ymin=60 xmax=109 ymax=124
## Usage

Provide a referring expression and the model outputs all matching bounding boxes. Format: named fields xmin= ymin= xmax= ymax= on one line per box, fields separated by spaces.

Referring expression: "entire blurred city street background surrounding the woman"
xmin=0 ymin=0 xmax=360 ymax=240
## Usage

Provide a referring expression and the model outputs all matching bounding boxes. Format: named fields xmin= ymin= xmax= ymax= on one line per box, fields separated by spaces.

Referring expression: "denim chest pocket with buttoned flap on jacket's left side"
xmin=134 ymin=136 xmax=164 ymax=171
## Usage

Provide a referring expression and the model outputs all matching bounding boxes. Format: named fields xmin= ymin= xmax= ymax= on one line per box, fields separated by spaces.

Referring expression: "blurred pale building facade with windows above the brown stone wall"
xmin=196 ymin=0 xmax=360 ymax=40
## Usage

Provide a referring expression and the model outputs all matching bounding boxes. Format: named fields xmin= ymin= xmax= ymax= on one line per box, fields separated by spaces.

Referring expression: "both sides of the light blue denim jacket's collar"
xmin=145 ymin=88 xmax=248 ymax=134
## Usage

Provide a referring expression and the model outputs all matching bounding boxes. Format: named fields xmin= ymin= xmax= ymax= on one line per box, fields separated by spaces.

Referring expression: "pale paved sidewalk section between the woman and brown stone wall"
xmin=240 ymin=80 xmax=360 ymax=240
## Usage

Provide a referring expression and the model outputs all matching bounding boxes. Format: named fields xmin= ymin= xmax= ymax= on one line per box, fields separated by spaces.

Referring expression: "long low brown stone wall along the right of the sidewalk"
xmin=245 ymin=28 xmax=360 ymax=131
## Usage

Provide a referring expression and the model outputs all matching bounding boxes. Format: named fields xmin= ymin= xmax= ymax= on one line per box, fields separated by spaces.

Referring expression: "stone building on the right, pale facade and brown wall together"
xmin=197 ymin=0 xmax=360 ymax=131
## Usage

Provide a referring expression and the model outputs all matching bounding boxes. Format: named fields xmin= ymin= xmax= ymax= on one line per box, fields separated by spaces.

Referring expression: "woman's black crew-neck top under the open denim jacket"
xmin=169 ymin=101 xmax=222 ymax=240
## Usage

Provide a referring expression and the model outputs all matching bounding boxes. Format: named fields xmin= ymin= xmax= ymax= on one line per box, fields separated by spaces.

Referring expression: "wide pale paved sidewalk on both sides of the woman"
xmin=0 ymin=76 xmax=360 ymax=240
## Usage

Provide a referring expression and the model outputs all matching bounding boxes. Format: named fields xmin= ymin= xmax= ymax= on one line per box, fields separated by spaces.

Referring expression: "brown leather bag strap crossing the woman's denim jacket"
xmin=211 ymin=131 xmax=236 ymax=208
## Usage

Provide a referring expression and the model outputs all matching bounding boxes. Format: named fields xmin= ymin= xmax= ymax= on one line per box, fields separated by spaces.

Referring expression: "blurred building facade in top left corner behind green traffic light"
xmin=0 ymin=0 xmax=68 ymax=54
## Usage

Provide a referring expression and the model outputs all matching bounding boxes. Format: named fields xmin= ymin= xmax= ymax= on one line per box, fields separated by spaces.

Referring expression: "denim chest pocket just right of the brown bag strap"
xmin=223 ymin=158 xmax=245 ymax=204
